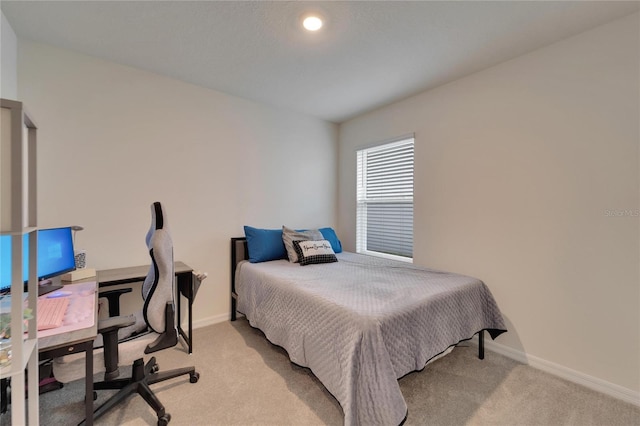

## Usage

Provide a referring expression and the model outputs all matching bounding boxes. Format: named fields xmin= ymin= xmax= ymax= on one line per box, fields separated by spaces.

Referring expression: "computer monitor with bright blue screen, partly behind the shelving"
xmin=0 ymin=227 xmax=76 ymax=292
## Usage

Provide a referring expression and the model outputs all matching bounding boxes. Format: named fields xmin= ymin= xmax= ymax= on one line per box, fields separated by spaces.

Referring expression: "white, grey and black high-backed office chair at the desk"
xmin=53 ymin=202 xmax=200 ymax=426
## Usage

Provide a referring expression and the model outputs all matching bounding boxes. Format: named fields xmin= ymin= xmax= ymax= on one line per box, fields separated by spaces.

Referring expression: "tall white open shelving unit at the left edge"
xmin=0 ymin=99 xmax=39 ymax=425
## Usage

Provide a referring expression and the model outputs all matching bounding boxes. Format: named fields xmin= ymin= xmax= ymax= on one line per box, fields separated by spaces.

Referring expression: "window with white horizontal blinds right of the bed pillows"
xmin=356 ymin=136 xmax=414 ymax=261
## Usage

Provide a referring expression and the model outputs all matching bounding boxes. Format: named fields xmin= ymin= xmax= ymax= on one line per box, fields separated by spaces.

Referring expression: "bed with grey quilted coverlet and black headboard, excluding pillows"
xmin=231 ymin=237 xmax=506 ymax=426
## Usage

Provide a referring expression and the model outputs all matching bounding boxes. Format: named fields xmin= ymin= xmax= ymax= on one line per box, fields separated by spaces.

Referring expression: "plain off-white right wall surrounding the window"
xmin=338 ymin=14 xmax=640 ymax=398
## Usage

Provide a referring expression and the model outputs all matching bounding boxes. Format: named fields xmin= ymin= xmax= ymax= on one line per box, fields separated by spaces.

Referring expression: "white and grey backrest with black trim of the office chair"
xmin=142 ymin=202 xmax=175 ymax=333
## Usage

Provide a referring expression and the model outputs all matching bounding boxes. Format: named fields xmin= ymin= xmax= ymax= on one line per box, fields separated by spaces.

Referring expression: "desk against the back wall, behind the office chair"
xmin=96 ymin=262 xmax=195 ymax=353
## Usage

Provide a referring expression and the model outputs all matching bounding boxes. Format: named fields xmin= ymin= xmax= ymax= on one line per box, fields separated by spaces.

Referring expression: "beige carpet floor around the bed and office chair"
xmin=0 ymin=319 xmax=640 ymax=426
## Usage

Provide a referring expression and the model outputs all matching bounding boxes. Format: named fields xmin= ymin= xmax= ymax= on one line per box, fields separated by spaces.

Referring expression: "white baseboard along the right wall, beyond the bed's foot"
xmin=472 ymin=337 xmax=640 ymax=407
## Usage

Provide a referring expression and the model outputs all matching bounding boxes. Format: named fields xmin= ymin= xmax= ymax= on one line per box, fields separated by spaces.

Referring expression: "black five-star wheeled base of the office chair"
xmin=80 ymin=357 xmax=200 ymax=426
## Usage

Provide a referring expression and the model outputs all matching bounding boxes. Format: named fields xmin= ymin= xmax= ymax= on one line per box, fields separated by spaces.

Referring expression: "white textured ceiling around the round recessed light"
xmin=0 ymin=0 xmax=640 ymax=122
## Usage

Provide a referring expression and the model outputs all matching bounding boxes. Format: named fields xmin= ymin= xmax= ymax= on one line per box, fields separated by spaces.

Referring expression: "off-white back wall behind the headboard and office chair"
xmin=18 ymin=40 xmax=337 ymax=322
